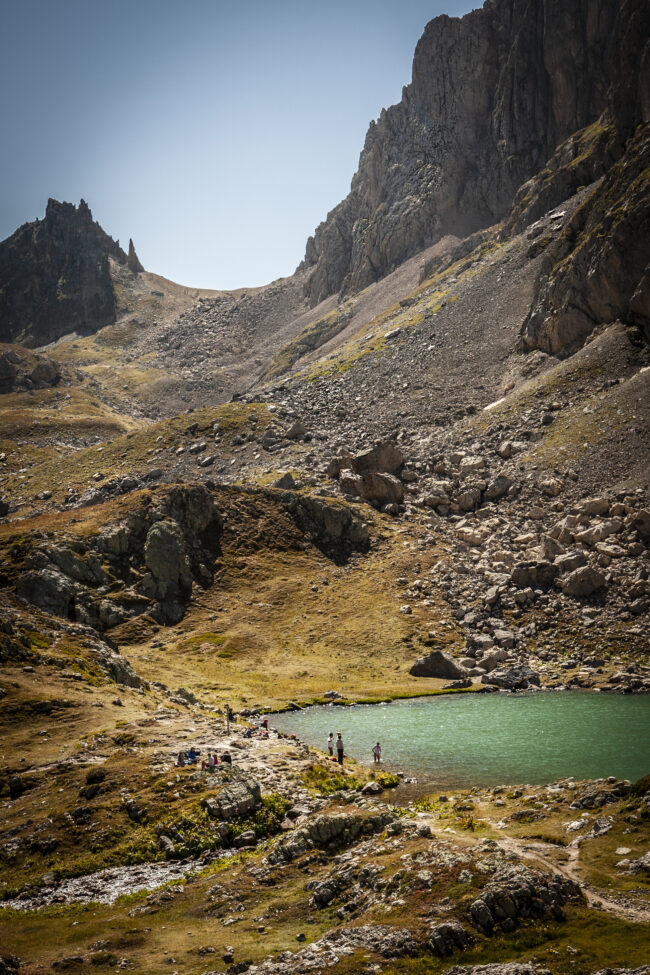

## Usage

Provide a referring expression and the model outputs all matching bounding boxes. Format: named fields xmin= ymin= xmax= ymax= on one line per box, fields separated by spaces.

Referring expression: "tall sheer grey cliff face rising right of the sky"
xmin=303 ymin=0 xmax=622 ymax=304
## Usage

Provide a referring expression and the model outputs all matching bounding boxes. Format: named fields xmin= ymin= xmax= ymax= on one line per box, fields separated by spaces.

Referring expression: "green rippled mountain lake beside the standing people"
xmin=269 ymin=691 xmax=650 ymax=786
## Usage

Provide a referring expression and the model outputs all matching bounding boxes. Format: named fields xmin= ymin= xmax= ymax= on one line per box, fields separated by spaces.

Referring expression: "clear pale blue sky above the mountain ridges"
xmin=0 ymin=0 xmax=480 ymax=288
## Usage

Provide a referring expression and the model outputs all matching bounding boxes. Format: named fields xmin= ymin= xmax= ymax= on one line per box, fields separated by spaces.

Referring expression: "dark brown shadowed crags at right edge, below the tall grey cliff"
xmin=516 ymin=0 xmax=650 ymax=355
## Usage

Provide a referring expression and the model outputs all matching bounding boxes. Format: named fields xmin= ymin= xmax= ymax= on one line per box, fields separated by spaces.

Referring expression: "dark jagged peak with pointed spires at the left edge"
xmin=0 ymin=200 xmax=141 ymax=346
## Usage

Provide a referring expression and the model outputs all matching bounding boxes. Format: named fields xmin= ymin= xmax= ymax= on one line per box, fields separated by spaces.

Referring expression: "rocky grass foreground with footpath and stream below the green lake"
xmin=0 ymin=687 xmax=650 ymax=975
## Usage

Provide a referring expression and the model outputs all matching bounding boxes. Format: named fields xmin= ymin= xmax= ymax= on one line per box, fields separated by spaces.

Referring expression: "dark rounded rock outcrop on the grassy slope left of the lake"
xmin=15 ymin=485 xmax=222 ymax=628
